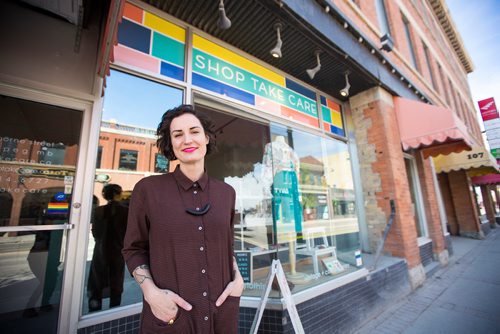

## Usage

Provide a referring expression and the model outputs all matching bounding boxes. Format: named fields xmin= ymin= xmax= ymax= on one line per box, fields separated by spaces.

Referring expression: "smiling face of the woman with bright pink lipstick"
xmin=170 ymin=113 xmax=208 ymax=163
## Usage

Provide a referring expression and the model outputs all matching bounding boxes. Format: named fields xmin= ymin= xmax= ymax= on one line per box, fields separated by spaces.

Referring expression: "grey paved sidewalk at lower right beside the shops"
xmin=355 ymin=228 xmax=500 ymax=334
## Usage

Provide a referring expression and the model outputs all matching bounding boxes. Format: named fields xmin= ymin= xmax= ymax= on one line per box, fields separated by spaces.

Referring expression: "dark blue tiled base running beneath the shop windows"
xmin=78 ymin=260 xmax=410 ymax=334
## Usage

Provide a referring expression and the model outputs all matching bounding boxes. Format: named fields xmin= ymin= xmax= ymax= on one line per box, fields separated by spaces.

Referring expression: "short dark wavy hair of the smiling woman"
xmin=156 ymin=104 xmax=215 ymax=160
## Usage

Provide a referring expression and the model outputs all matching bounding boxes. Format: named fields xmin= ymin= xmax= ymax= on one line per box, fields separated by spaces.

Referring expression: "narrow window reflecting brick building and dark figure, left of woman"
xmin=82 ymin=70 xmax=183 ymax=314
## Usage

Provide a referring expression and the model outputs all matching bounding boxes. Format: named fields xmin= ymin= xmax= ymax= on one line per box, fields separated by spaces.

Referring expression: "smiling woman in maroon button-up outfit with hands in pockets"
xmin=123 ymin=105 xmax=243 ymax=334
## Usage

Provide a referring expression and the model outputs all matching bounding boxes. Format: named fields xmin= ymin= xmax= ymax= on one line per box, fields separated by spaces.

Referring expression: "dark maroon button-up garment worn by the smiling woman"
xmin=123 ymin=167 xmax=239 ymax=334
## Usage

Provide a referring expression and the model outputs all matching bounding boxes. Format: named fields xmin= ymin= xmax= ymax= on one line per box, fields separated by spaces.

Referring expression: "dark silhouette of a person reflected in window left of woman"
xmin=87 ymin=184 xmax=128 ymax=312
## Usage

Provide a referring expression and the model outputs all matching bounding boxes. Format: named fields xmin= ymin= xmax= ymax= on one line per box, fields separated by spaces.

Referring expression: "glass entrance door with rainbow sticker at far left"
xmin=0 ymin=95 xmax=83 ymax=333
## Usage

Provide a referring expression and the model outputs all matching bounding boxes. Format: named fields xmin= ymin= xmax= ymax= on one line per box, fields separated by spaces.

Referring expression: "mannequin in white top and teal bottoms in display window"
xmin=263 ymin=136 xmax=305 ymax=284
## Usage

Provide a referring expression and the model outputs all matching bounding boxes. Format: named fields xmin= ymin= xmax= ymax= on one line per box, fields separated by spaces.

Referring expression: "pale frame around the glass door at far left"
xmin=0 ymin=83 xmax=100 ymax=334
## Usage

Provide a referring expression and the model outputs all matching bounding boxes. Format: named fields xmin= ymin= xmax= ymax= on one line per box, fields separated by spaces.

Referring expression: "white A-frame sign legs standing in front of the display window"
xmin=250 ymin=260 xmax=305 ymax=334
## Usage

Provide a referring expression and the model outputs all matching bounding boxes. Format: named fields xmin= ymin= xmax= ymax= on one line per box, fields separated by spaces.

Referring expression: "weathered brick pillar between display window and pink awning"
xmin=350 ymin=88 xmax=420 ymax=268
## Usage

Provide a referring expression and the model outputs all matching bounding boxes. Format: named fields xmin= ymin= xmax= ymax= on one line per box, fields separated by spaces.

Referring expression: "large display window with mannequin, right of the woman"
xmin=197 ymin=106 xmax=362 ymax=297
